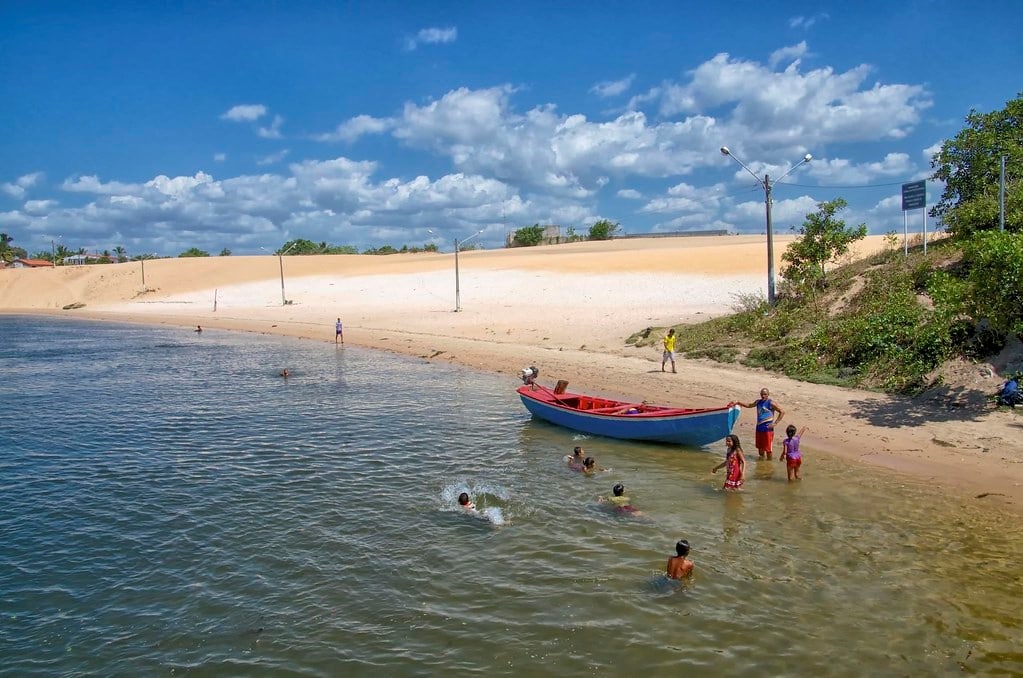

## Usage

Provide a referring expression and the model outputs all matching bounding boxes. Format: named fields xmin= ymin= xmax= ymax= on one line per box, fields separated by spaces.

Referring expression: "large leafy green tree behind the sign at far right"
xmin=931 ymin=92 xmax=1023 ymax=236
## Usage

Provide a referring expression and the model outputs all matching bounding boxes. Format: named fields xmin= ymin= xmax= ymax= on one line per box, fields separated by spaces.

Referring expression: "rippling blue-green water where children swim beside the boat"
xmin=0 ymin=318 xmax=1023 ymax=676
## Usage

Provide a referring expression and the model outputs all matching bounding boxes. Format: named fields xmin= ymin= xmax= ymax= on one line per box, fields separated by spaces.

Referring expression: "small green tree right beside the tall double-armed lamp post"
xmin=782 ymin=197 xmax=866 ymax=291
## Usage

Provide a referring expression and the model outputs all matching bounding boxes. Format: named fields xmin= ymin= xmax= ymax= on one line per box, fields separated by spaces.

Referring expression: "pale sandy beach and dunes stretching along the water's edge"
xmin=0 ymin=235 xmax=1023 ymax=511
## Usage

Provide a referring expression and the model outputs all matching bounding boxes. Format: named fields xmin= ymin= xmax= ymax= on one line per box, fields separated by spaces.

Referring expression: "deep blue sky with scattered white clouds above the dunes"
xmin=0 ymin=0 xmax=1023 ymax=256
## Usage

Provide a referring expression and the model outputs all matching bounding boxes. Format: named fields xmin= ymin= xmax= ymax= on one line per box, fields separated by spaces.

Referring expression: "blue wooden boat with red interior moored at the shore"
xmin=518 ymin=368 xmax=740 ymax=447
